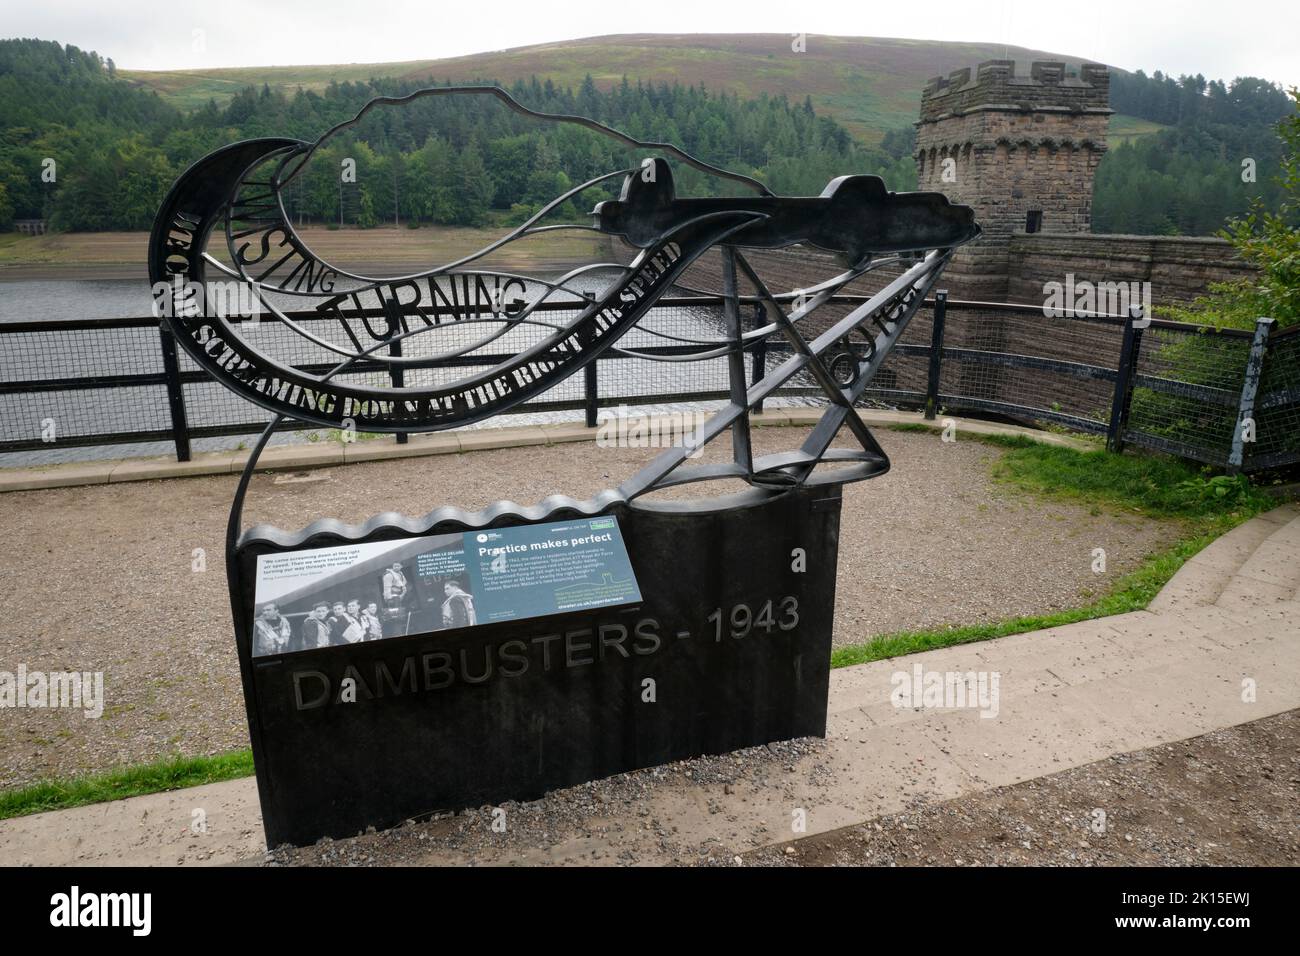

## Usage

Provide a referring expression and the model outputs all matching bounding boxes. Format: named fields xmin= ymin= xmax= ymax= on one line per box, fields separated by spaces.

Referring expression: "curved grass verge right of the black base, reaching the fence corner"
xmin=831 ymin=425 xmax=1278 ymax=667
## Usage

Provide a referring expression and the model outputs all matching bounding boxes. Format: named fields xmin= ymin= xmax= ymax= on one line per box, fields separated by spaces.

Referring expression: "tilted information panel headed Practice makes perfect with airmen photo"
xmin=252 ymin=515 xmax=641 ymax=657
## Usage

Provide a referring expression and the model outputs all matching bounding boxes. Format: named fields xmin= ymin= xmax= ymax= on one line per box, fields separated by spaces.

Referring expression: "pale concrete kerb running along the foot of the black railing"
xmin=0 ymin=407 xmax=1096 ymax=493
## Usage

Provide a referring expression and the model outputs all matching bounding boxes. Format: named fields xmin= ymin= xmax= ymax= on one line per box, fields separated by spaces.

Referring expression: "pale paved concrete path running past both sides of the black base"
xmin=0 ymin=505 xmax=1300 ymax=865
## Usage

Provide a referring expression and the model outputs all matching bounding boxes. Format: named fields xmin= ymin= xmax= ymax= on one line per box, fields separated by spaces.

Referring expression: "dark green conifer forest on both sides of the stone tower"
xmin=0 ymin=38 xmax=1290 ymax=235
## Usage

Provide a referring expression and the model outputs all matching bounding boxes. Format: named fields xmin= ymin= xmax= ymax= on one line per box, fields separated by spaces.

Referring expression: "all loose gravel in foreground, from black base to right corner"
xmin=264 ymin=711 xmax=1300 ymax=866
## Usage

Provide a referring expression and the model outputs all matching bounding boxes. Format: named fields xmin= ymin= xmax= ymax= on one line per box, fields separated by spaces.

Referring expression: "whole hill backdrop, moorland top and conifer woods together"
xmin=0 ymin=34 xmax=1294 ymax=235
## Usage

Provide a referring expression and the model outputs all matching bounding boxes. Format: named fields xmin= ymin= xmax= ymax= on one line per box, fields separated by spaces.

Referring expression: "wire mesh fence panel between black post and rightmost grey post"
xmin=1125 ymin=325 xmax=1251 ymax=464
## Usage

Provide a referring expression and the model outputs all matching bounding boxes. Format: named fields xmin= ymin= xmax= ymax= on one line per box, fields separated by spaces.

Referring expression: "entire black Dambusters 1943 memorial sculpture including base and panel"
xmin=150 ymin=87 xmax=980 ymax=845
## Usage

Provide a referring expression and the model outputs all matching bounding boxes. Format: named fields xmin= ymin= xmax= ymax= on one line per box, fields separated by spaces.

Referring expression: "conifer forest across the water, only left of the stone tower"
xmin=0 ymin=40 xmax=915 ymax=230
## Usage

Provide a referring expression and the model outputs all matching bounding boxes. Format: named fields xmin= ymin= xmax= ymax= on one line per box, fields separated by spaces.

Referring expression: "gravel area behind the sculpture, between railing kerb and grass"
xmin=0 ymin=428 xmax=1178 ymax=787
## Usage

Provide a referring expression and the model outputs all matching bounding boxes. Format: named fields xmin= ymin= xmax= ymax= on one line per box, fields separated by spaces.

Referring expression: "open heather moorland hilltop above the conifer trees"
xmin=120 ymin=34 xmax=1097 ymax=143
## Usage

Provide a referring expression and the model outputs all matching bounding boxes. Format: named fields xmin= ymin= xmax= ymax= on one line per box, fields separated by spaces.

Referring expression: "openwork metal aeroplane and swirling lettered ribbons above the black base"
xmin=150 ymin=87 xmax=979 ymax=507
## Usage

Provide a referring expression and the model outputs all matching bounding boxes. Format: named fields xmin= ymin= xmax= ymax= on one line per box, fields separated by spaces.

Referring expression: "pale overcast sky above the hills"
xmin=0 ymin=0 xmax=1300 ymax=86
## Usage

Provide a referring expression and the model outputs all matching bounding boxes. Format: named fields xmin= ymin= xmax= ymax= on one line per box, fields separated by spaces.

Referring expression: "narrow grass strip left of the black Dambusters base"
xmin=0 ymin=749 xmax=252 ymax=819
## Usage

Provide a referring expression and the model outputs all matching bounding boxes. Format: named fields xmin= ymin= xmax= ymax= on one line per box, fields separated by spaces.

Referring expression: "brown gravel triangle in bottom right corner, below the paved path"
xmin=738 ymin=710 xmax=1300 ymax=866
